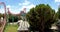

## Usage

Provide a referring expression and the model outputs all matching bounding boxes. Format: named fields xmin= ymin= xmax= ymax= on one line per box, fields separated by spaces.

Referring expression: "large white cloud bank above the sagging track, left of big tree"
xmin=0 ymin=0 xmax=35 ymax=14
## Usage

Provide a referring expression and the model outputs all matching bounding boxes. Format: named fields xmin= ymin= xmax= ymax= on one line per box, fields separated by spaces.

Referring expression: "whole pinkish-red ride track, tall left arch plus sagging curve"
xmin=0 ymin=2 xmax=26 ymax=32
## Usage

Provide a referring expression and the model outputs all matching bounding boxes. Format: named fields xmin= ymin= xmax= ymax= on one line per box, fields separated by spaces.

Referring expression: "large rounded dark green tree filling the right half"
xmin=26 ymin=4 xmax=56 ymax=32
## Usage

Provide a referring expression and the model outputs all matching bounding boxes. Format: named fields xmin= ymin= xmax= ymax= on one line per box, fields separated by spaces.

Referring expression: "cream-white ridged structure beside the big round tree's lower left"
xmin=18 ymin=20 xmax=30 ymax=31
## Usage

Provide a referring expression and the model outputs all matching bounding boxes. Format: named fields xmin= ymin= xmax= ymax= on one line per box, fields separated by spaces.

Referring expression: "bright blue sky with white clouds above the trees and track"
xmin=0 ymin=0 xmax=60 ymax=14
